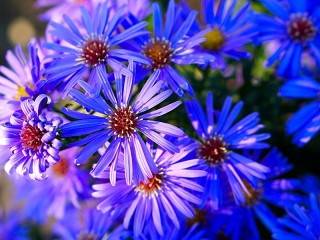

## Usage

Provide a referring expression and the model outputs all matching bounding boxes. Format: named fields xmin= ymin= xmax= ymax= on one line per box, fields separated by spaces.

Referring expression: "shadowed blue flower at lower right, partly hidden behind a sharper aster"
xmin=226 ymin=148 xmax=305 ymax=239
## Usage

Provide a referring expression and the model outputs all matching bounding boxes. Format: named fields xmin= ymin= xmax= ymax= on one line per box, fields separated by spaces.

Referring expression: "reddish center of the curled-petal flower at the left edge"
xmin=20 ymin=125 xmax=46 ymax=149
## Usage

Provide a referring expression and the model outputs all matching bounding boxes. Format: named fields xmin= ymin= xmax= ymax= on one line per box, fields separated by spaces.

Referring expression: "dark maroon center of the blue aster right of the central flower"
xmin=198 ymin=136 xmax=228 ymax=165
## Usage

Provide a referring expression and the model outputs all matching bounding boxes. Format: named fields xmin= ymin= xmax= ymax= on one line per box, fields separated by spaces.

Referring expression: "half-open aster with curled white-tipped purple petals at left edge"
xmin=0 ymin=94 xmax=62 ymax=180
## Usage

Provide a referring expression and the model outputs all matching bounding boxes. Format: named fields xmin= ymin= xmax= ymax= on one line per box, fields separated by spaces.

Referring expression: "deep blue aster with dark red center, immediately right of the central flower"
xmin=185 ymin=92 xmax=270 ymax=209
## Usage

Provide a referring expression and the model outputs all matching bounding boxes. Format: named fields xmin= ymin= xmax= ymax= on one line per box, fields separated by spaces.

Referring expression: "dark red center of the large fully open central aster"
xmin=108 ymin=106 xmax=139 ymax=138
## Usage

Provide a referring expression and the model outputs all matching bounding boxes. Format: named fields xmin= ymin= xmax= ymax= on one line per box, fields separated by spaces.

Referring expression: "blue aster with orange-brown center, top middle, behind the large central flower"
xmin=126 ymin=0 xmax=214 ymax=97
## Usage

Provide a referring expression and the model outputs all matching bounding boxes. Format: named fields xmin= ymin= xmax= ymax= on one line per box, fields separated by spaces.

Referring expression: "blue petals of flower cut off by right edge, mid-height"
xmin=279 ymin=76 xmax=320 ymax=147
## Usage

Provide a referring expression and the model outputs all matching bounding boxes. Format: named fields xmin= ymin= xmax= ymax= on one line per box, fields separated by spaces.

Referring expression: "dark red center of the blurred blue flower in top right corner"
xmin=287 ymin=13 xmax=318 ymax=42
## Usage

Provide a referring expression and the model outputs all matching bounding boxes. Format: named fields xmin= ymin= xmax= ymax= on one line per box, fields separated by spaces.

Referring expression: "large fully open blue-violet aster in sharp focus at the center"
xmin=61 ymin=63 xmax=184 ymax=185
